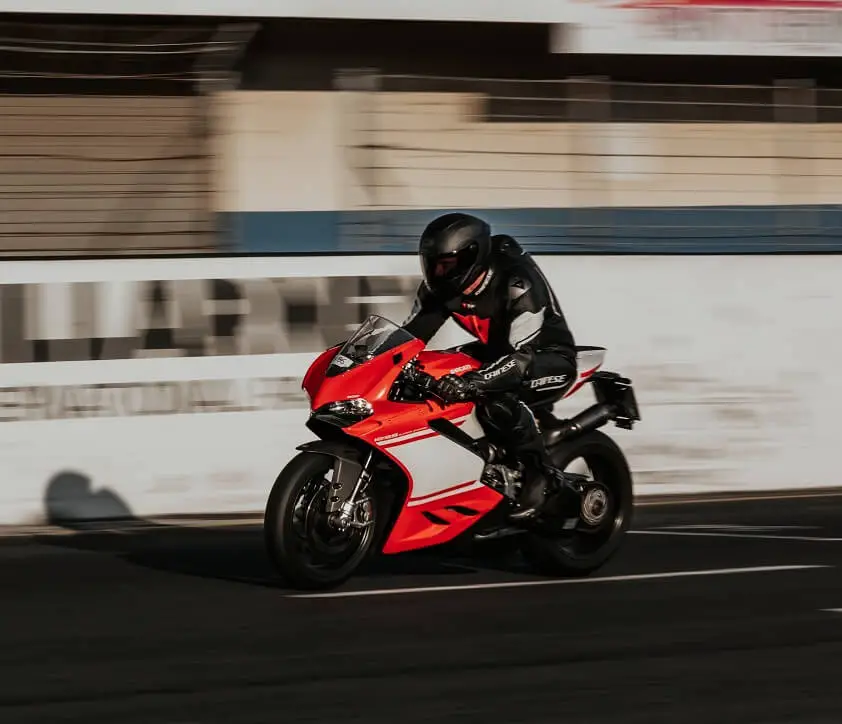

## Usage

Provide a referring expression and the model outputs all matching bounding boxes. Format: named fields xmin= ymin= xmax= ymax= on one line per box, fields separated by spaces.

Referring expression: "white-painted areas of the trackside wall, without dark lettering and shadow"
xmin=0 ymin=256 xmax=842 ymax=524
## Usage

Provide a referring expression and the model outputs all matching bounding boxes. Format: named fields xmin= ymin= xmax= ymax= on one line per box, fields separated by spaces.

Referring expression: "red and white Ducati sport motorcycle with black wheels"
xmin=264 ymin=315 xmax=640 ymax=590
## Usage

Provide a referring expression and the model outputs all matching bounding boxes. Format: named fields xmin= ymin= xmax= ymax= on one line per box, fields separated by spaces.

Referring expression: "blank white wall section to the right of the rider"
xmin=549 ymin=256 xmax=842 ymax=494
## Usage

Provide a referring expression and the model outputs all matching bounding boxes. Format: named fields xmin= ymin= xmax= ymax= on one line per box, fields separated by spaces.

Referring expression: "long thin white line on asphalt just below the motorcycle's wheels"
xmin=287 ymin=565 xmax=832 ymax=598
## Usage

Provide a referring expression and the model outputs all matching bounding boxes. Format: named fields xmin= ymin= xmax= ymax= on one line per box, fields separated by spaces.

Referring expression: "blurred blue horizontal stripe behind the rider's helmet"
xmin=222 ymin=204 xmax=842 ymax=254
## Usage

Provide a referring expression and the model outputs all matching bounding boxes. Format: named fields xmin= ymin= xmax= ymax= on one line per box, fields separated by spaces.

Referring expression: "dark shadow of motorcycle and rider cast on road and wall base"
xmin=36 ymin=471 xmax=526 ymax=589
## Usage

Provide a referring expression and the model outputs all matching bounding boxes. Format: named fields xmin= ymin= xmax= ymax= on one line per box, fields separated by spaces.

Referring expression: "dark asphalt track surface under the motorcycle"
xmin=0 ymin=495 xmax=842 ymax=724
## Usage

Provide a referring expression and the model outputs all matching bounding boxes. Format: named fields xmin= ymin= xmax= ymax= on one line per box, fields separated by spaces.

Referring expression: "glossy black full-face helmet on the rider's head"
xmin=418 ymin=213 xmax=491 ymax=296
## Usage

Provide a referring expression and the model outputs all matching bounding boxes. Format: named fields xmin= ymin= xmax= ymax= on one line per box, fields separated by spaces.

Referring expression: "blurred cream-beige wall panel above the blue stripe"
xmin=212 ymin=88 xmax=842 ymax=211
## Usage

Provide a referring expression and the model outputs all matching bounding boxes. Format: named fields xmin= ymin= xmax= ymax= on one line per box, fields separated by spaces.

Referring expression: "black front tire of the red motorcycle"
xmin=263 ymin=452 xmax=377 ymax=590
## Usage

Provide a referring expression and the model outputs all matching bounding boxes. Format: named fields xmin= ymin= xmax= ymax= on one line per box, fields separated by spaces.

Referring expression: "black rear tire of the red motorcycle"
xmin=521 ymin=430 xmax=634 ymax=576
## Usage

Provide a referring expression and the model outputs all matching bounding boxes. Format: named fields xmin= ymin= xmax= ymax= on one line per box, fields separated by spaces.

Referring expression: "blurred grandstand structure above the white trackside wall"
xmin=0 ymin=0 xmax=842 ymax=257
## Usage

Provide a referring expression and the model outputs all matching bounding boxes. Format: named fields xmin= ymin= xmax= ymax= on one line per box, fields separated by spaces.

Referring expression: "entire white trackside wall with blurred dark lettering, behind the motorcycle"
xmin=0 ymin=256 xmax=842 ymax=525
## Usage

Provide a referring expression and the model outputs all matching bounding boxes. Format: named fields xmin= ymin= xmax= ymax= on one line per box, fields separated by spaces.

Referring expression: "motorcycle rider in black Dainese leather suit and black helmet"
xmin=403 ymin=213 xmax=576 ymax=520
